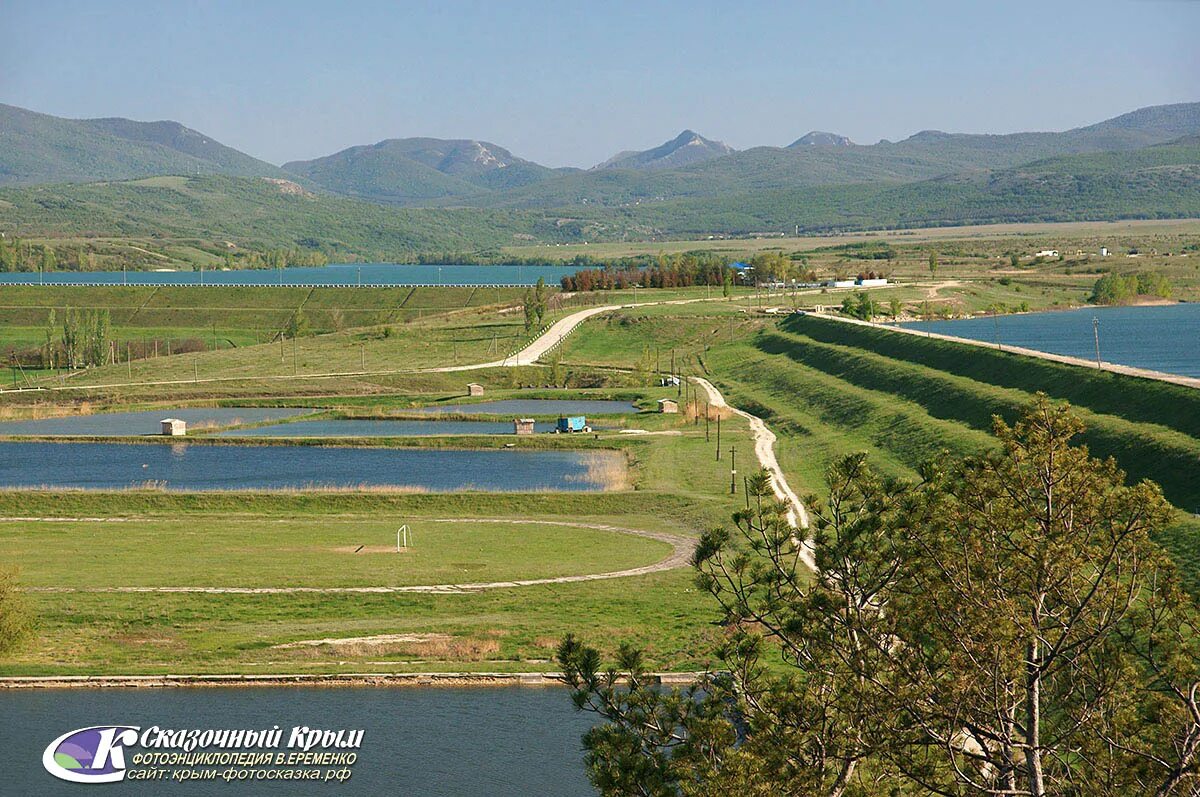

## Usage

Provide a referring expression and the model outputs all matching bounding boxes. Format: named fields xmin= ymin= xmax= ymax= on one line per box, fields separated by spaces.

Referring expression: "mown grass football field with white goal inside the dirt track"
xmin=0 ymin=514 xmax=683 ymax=588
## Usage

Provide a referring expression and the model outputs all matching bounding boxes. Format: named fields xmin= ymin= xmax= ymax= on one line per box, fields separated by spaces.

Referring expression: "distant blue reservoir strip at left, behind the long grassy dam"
xmin=0 ymin=263 xmax=577 ymax=287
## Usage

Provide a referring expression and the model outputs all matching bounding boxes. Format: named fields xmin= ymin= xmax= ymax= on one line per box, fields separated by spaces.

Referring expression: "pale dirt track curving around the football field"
xmin=25 ymin=517 xmax=696 ymax=595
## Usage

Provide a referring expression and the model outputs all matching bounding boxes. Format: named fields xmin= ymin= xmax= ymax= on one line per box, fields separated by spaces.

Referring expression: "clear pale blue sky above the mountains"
xmin=0 ymin=0 xmax=1200 ymax=166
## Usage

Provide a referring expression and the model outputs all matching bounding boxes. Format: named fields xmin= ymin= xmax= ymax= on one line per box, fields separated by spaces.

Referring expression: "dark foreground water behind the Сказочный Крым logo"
xmin=0 ymin=687 xmax=595 ymax=797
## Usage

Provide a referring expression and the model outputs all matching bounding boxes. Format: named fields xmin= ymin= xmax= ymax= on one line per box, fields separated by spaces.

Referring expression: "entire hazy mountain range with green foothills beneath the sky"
xmin=0 ymin=103 xmax=1200 ymax=252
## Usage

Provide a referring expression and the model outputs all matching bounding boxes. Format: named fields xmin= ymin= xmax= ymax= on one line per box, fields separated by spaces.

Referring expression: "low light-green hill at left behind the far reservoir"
xmin=0 ymin=176 xmax=600 ymax=259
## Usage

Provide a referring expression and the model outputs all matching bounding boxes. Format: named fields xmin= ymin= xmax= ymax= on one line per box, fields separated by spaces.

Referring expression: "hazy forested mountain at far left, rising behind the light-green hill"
xmin=0 ymin=104 xmax=283 ymax=185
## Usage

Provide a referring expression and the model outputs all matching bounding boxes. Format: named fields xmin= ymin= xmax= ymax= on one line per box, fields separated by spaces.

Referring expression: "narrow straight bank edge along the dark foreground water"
xmin=0 ymin=672 xmax=703 ymax=691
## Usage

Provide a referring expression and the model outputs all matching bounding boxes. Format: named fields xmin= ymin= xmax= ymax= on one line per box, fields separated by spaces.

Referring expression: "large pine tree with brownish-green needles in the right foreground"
xmin=558 ymin=397 xmax=1200 ymax=797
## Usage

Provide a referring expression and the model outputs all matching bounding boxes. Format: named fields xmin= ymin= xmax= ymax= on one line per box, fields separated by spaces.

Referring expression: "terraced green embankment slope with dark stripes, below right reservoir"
xmin=706 ymin=317 xmax=1200 ymax=588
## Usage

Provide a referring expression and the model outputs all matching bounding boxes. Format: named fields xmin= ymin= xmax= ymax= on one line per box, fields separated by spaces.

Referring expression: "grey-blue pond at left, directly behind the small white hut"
xmin=0 ymin=407 xmax=316 ymax=437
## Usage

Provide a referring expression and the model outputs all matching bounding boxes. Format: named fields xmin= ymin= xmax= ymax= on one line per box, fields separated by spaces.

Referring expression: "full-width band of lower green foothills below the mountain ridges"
xmin=0 ymin=138 xmax=1200 ymax=259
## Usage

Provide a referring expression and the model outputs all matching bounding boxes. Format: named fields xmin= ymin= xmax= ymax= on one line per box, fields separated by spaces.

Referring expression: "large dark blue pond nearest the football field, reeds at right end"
xmin=0 ymin=443 xmax=625 ymax=492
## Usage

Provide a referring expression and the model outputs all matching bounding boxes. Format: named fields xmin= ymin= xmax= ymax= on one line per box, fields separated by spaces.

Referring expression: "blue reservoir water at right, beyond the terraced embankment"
xmin=905 ymin=304 xmax=1200 ymax=377
